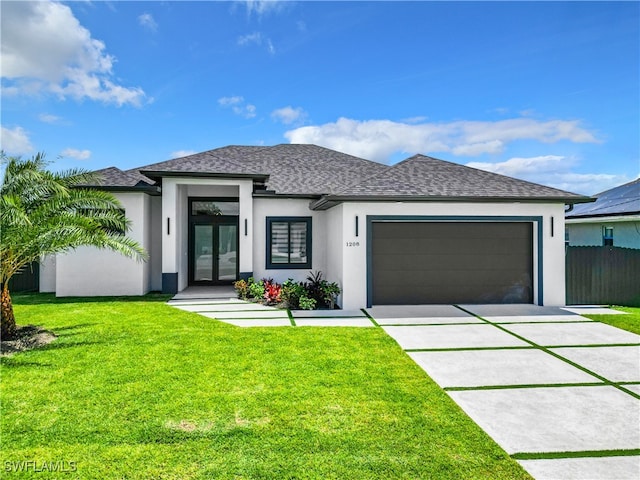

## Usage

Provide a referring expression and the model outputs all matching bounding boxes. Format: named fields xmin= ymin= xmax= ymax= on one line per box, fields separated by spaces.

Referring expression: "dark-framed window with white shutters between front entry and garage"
xmin=267 ymin=217 xmax=311 ymax=268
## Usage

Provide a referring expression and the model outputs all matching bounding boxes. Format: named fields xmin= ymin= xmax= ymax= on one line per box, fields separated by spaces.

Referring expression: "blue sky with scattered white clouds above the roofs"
xmin=0 ymin=1 xmax=640 ymax=194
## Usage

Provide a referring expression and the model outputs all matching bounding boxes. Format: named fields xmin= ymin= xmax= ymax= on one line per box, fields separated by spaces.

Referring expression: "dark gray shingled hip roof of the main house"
xmin=89 ymin=144 xmax=592 ymax=209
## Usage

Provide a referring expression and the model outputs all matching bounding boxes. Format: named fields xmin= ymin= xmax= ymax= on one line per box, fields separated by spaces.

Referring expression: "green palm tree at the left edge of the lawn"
xmin=0 ymin=153 xmax=147 ymax=338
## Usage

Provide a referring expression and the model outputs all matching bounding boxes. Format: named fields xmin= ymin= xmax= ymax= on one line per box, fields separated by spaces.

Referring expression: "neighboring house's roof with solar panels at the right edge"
xmin=566 ymin=178 xmax=640 ymax=218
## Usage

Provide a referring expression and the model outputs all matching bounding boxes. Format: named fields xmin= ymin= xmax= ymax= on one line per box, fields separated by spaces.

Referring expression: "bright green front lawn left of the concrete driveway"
xmin=0 ymin=295 xmax=530 ymax=479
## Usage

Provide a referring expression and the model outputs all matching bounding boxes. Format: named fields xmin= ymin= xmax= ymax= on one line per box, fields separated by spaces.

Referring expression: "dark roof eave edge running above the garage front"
xmin=309 ymin=195 xmax=596 ymax=210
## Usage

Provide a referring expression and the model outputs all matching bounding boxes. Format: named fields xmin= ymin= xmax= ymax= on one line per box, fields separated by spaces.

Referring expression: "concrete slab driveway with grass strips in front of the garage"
xmin=366 ymin=305 xmax=640 ymax=480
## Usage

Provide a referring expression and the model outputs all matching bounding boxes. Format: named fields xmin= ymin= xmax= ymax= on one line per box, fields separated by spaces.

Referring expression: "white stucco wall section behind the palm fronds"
xmin=55 ymin=193 xmax=150 ymax=297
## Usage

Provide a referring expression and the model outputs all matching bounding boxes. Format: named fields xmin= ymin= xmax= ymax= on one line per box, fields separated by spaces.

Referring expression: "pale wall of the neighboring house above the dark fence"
xmin=566 ymin=216 xmax=640 ymax=249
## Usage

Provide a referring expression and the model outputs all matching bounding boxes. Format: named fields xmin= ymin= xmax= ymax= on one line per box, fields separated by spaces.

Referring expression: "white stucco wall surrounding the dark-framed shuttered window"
xmin=253 ymin=198 xmax=333 ymax=282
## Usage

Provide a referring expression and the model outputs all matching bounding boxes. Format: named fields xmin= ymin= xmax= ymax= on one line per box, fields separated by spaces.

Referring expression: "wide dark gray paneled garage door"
xmin=370 ymin=222 xmax=533 ymax=305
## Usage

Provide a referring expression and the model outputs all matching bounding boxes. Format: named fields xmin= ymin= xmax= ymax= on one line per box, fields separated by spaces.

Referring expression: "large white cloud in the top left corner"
xmin=1 ymin=2 xmax=145 ymax=106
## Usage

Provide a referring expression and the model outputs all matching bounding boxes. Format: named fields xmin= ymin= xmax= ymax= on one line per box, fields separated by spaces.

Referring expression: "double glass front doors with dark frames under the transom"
xmin=189 ymin=221 xmax=238 ymax=285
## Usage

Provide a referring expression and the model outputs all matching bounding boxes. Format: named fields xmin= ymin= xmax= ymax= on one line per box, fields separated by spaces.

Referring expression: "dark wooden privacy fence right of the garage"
xmin=566 ymin=247 xmax=640 ymax=306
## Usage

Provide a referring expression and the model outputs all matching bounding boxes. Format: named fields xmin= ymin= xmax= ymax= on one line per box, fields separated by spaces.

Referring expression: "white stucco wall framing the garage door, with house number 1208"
xmin=332 ymin=202 xmax=565 ymax=309
